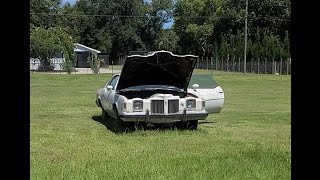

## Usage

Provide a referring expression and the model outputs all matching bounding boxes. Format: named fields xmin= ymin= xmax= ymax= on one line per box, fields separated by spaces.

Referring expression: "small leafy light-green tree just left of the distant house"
xmin=30 ymin=27 xmax=75 ymax=74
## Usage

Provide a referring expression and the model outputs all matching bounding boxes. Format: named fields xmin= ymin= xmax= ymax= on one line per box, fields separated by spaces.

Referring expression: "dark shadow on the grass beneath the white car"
xmin=92 ymin=115 xmax=215 ymax=134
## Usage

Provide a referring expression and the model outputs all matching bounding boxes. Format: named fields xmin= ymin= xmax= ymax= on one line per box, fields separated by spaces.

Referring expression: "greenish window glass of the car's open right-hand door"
xmin=188 ymin=75 xmax=218 ymax=89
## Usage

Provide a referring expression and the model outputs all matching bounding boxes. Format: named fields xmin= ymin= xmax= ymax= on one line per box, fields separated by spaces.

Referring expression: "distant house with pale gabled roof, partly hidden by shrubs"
xmin=30 ymin=43 xmax=109 ymax=70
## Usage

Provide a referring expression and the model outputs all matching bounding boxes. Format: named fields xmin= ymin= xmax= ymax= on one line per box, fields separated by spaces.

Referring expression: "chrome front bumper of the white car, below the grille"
xmin=120 ymin=110 xmax=208 ymax=123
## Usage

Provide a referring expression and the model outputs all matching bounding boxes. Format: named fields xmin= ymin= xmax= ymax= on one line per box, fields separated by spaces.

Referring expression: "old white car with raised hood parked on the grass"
xmin=96 ymin=51 xmax=224 ymax=129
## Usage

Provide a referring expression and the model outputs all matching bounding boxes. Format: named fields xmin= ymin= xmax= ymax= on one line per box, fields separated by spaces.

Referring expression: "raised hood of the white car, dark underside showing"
xmin=117 ymin=51 xmax=197 ymax=92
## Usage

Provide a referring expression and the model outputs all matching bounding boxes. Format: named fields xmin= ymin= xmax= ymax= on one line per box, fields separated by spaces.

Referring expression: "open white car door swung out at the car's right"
xmin=188 ymin=75 xmax=224 ymax=113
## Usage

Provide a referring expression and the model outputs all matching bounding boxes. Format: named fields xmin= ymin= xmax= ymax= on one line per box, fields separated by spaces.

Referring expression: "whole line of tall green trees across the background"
xmin=30 ymin=0 xmax=291 ymax=71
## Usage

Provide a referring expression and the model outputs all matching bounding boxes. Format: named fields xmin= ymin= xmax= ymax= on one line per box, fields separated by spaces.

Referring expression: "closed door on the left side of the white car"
xmin=101 ymin=75 xmax=119 ymax=113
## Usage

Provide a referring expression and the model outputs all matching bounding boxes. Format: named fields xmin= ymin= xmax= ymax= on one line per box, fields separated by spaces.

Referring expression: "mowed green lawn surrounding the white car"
xmin=30 ymin=70 xmax=291 ymax=180
